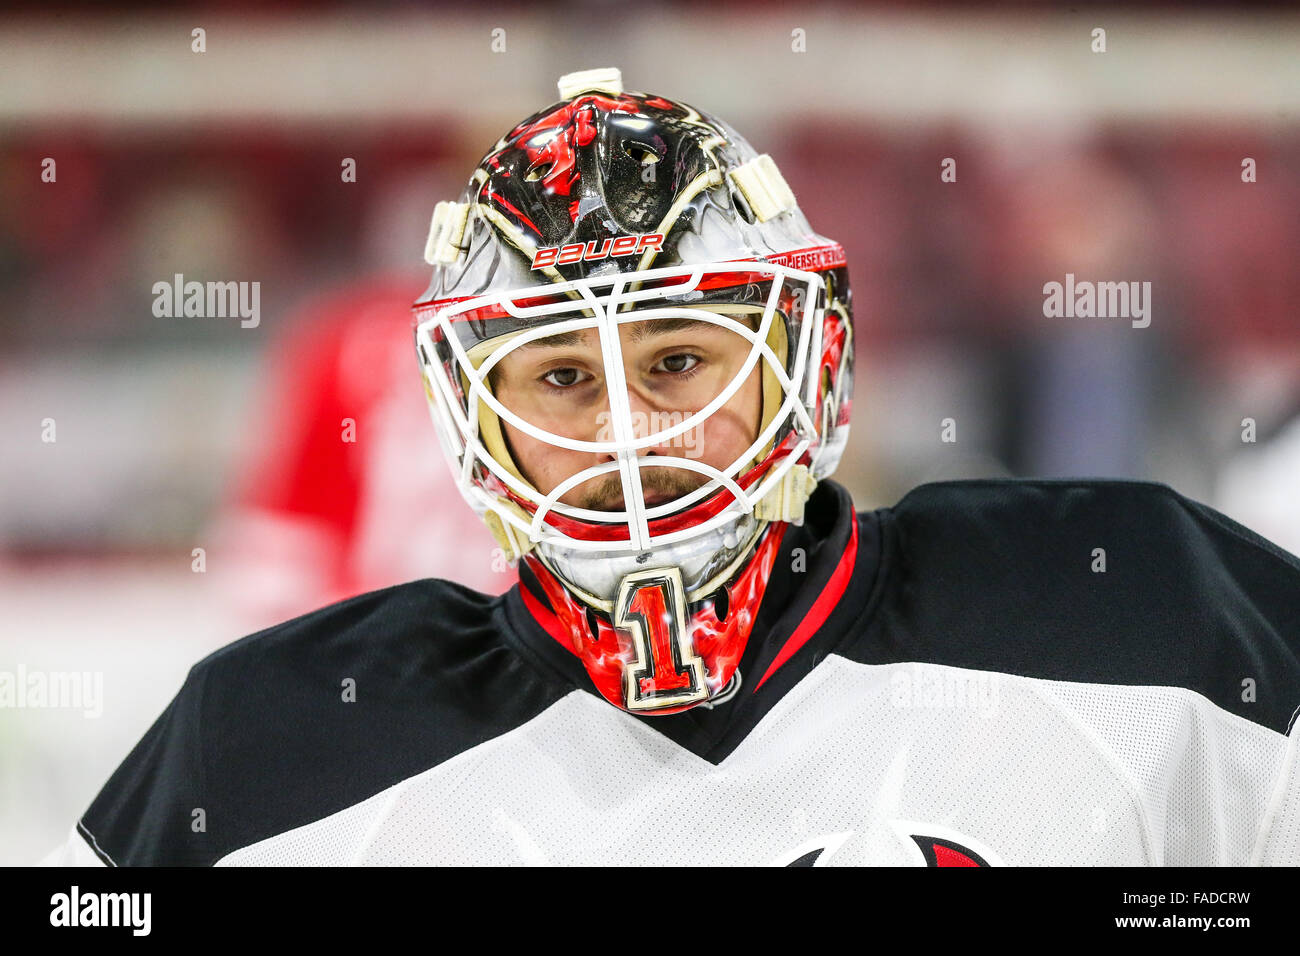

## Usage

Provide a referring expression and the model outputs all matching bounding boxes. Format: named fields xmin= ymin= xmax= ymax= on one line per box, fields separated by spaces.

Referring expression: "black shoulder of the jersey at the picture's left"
xmin=78 ymin=579 xmax=572 ymax=865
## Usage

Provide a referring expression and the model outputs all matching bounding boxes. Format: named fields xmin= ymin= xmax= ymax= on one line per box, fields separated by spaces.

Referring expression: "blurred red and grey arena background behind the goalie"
xmin=0 ymin=1 xmax=1300 ymax=864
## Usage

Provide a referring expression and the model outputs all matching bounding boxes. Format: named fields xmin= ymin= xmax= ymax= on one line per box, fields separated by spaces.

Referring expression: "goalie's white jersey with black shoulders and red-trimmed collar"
xmin=38 ymin=480 xmax=1300 ymax=866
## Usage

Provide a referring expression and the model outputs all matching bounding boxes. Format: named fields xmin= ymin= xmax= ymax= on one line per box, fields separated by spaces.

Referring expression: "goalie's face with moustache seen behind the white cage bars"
xmin=493 ymin=319 xmax=762 ymax=511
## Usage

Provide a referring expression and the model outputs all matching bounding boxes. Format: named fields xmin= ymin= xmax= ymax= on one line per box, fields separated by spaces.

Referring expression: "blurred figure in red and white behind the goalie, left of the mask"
xmin=212 ymin=273 xmax=516 ymax=628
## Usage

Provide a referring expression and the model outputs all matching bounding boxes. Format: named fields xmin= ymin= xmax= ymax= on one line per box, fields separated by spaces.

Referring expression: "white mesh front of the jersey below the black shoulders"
xmin=202 ymin=656 xmax=1284 ymax=865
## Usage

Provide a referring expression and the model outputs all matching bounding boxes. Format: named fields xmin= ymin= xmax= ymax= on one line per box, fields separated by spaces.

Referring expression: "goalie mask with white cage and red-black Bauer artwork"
xmin=413 ymin=70 xmax=853 ymax=714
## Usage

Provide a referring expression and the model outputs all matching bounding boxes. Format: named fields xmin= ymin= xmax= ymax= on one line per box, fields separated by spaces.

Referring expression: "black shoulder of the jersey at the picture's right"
xmin=841 ymin=479 xmax=1300 ymax=734
